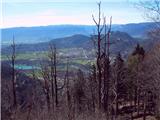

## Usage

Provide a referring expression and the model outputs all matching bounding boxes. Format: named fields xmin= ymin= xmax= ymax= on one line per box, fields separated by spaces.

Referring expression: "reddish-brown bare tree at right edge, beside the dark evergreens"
xmin=144 ymin=44 xmax=160 ymax=116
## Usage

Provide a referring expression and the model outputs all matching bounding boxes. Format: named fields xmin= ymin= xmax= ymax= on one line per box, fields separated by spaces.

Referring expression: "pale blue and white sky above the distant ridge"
xmin=0 ymin=0 xmax=150 ymax=28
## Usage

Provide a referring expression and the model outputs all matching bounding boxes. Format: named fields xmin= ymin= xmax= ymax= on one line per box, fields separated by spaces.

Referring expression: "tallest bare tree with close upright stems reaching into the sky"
xmin=92 ymin=2 xmax=112 ymax=116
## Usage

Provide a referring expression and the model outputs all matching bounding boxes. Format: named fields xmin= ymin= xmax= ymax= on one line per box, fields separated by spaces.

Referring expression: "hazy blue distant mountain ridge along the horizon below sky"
xmin=1 ymin=22 xmax=155 ymax=45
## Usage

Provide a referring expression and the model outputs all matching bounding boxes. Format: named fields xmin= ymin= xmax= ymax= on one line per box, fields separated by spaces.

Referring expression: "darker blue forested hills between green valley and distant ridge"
xmin=2 ymin=31 xmax=141 ymax=54
